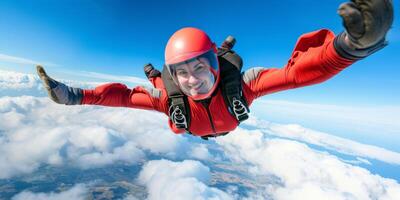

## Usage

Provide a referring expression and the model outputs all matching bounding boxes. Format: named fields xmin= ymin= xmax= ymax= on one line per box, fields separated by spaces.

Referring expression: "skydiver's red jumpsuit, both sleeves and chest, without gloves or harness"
xmin=82 ymin=29 xmax=354 ymax=136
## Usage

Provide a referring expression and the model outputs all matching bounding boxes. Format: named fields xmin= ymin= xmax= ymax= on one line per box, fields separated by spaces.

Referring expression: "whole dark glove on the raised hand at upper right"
xmin=335 ymin=0 xmax=393 ymax=59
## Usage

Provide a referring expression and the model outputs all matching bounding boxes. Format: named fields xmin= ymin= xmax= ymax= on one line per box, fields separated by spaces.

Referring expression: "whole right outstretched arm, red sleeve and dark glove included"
xmin=243 ymin=0 xmax=393 ymax=102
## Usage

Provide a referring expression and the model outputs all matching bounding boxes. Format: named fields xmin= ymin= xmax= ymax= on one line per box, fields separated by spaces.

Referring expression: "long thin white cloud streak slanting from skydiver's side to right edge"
xmin=245 ymin=117 xmax=400 ymax=165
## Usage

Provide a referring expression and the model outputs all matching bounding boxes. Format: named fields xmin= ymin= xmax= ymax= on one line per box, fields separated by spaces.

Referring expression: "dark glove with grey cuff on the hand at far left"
xmin=36 ymin=65 xmax=83 ymax=105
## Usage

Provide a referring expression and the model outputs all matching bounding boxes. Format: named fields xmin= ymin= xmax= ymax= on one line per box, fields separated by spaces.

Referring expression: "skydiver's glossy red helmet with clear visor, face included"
xmin=165 ymin=27 xmax=220 ymax=100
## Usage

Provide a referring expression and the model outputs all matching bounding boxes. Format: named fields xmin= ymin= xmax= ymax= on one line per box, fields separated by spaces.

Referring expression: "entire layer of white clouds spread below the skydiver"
xmin=0 ymin=69 xmax=400 ymax=199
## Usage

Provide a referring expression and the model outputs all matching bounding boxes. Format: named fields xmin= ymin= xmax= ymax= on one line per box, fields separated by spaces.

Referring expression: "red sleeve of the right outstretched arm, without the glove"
xmin=243 ymin=29 xmax=355 ymax=101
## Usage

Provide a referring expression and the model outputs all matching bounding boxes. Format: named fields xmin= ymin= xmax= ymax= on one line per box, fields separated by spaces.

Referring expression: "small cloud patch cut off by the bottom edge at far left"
xmin=12 ymin=184 xmax=88 ymax=200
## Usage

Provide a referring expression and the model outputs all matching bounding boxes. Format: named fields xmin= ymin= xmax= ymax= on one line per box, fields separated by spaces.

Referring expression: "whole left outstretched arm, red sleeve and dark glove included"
xmin=37 ymin=66 xmax=165 ymax=112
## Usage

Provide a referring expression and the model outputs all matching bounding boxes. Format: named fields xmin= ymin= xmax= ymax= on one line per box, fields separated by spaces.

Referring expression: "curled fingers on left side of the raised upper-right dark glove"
xmin=338 ymin=2 xmax=365 ymax=39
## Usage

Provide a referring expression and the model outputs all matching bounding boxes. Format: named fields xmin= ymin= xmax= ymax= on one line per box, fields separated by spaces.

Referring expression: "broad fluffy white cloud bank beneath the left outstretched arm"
xmin=0 ymin=96 xmax=192 ymax=178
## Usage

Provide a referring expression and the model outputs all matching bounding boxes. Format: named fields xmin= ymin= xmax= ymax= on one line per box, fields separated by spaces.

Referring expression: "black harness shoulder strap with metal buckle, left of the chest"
xmin=161 ymin=65 xmax=190 ymax=131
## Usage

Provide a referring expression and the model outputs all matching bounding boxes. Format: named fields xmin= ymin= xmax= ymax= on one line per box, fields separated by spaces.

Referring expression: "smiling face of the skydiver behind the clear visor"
xmin=175 ymin=57 xmax=215 ymax=96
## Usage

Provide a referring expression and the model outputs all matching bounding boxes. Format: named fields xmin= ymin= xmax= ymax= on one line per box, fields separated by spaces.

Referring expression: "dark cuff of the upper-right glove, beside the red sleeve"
xmin=333 ymin=32 xmax=387 ymax=60
